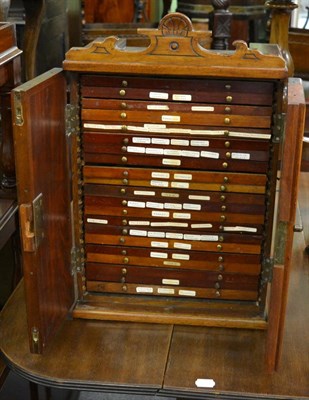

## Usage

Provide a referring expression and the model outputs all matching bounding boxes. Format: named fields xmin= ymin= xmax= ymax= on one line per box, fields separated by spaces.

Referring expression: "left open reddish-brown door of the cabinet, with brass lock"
xmin=12 ymin=68 xmax=74 ymax=353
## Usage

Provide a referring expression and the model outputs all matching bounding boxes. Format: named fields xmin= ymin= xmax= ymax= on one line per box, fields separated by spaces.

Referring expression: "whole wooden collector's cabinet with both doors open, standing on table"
xmin=13 ymin=13 xmax=305 ymax=368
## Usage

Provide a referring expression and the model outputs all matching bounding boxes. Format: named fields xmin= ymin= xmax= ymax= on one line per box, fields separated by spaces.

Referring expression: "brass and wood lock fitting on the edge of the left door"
xmin=19 ymin=193 xmax=44 ymax=252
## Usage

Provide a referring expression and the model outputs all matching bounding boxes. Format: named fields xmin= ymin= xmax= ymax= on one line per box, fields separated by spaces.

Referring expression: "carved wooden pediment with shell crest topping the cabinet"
xmin=63 ymin=13 xmax=288 ymax=79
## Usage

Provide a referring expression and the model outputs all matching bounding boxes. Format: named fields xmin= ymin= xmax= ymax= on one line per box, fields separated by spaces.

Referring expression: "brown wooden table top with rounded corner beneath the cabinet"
xmin=0 ymin=223 xmax=309 ymax=399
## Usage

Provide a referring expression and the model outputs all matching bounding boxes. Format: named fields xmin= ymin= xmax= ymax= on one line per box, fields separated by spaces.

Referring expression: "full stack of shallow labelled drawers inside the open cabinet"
xmin=80 ymin=74 xmax=277 ymax=302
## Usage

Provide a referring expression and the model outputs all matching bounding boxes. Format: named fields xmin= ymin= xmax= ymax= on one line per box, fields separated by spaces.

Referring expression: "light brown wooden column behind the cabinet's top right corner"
xmin=265 ymin=0 xmax=297 ymax=76
